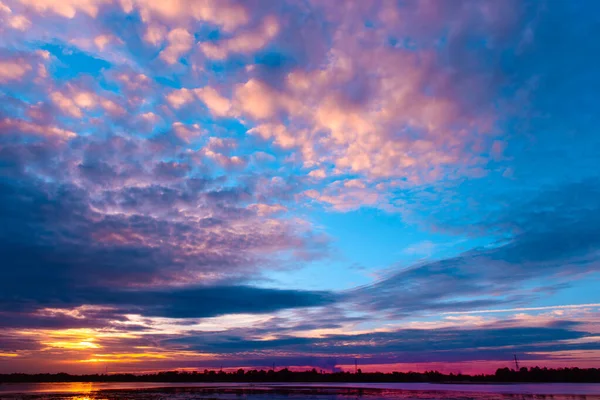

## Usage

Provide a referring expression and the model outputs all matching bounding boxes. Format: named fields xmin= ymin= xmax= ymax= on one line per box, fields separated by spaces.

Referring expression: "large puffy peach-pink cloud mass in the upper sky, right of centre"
xmin=235 ymin=48 xmax=490 ymax=186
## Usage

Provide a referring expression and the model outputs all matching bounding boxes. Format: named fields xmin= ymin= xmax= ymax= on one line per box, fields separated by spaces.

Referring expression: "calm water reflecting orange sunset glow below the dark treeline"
xmin=0 ymin=382 xmax=600 ymax=400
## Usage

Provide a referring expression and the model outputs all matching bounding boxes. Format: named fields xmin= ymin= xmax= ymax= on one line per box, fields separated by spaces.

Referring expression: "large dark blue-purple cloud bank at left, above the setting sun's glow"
xmin=0 ymin=139 xmax=333 ymax=319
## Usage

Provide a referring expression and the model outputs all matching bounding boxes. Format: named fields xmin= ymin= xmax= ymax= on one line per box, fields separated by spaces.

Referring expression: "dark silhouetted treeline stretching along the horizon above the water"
xmin=0 ymin=367 xmax=600 ymax=383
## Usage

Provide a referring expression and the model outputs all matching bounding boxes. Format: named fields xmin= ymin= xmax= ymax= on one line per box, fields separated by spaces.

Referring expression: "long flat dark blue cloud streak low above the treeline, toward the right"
xmin=167 ymin=325 xmax=598 ymax=366
